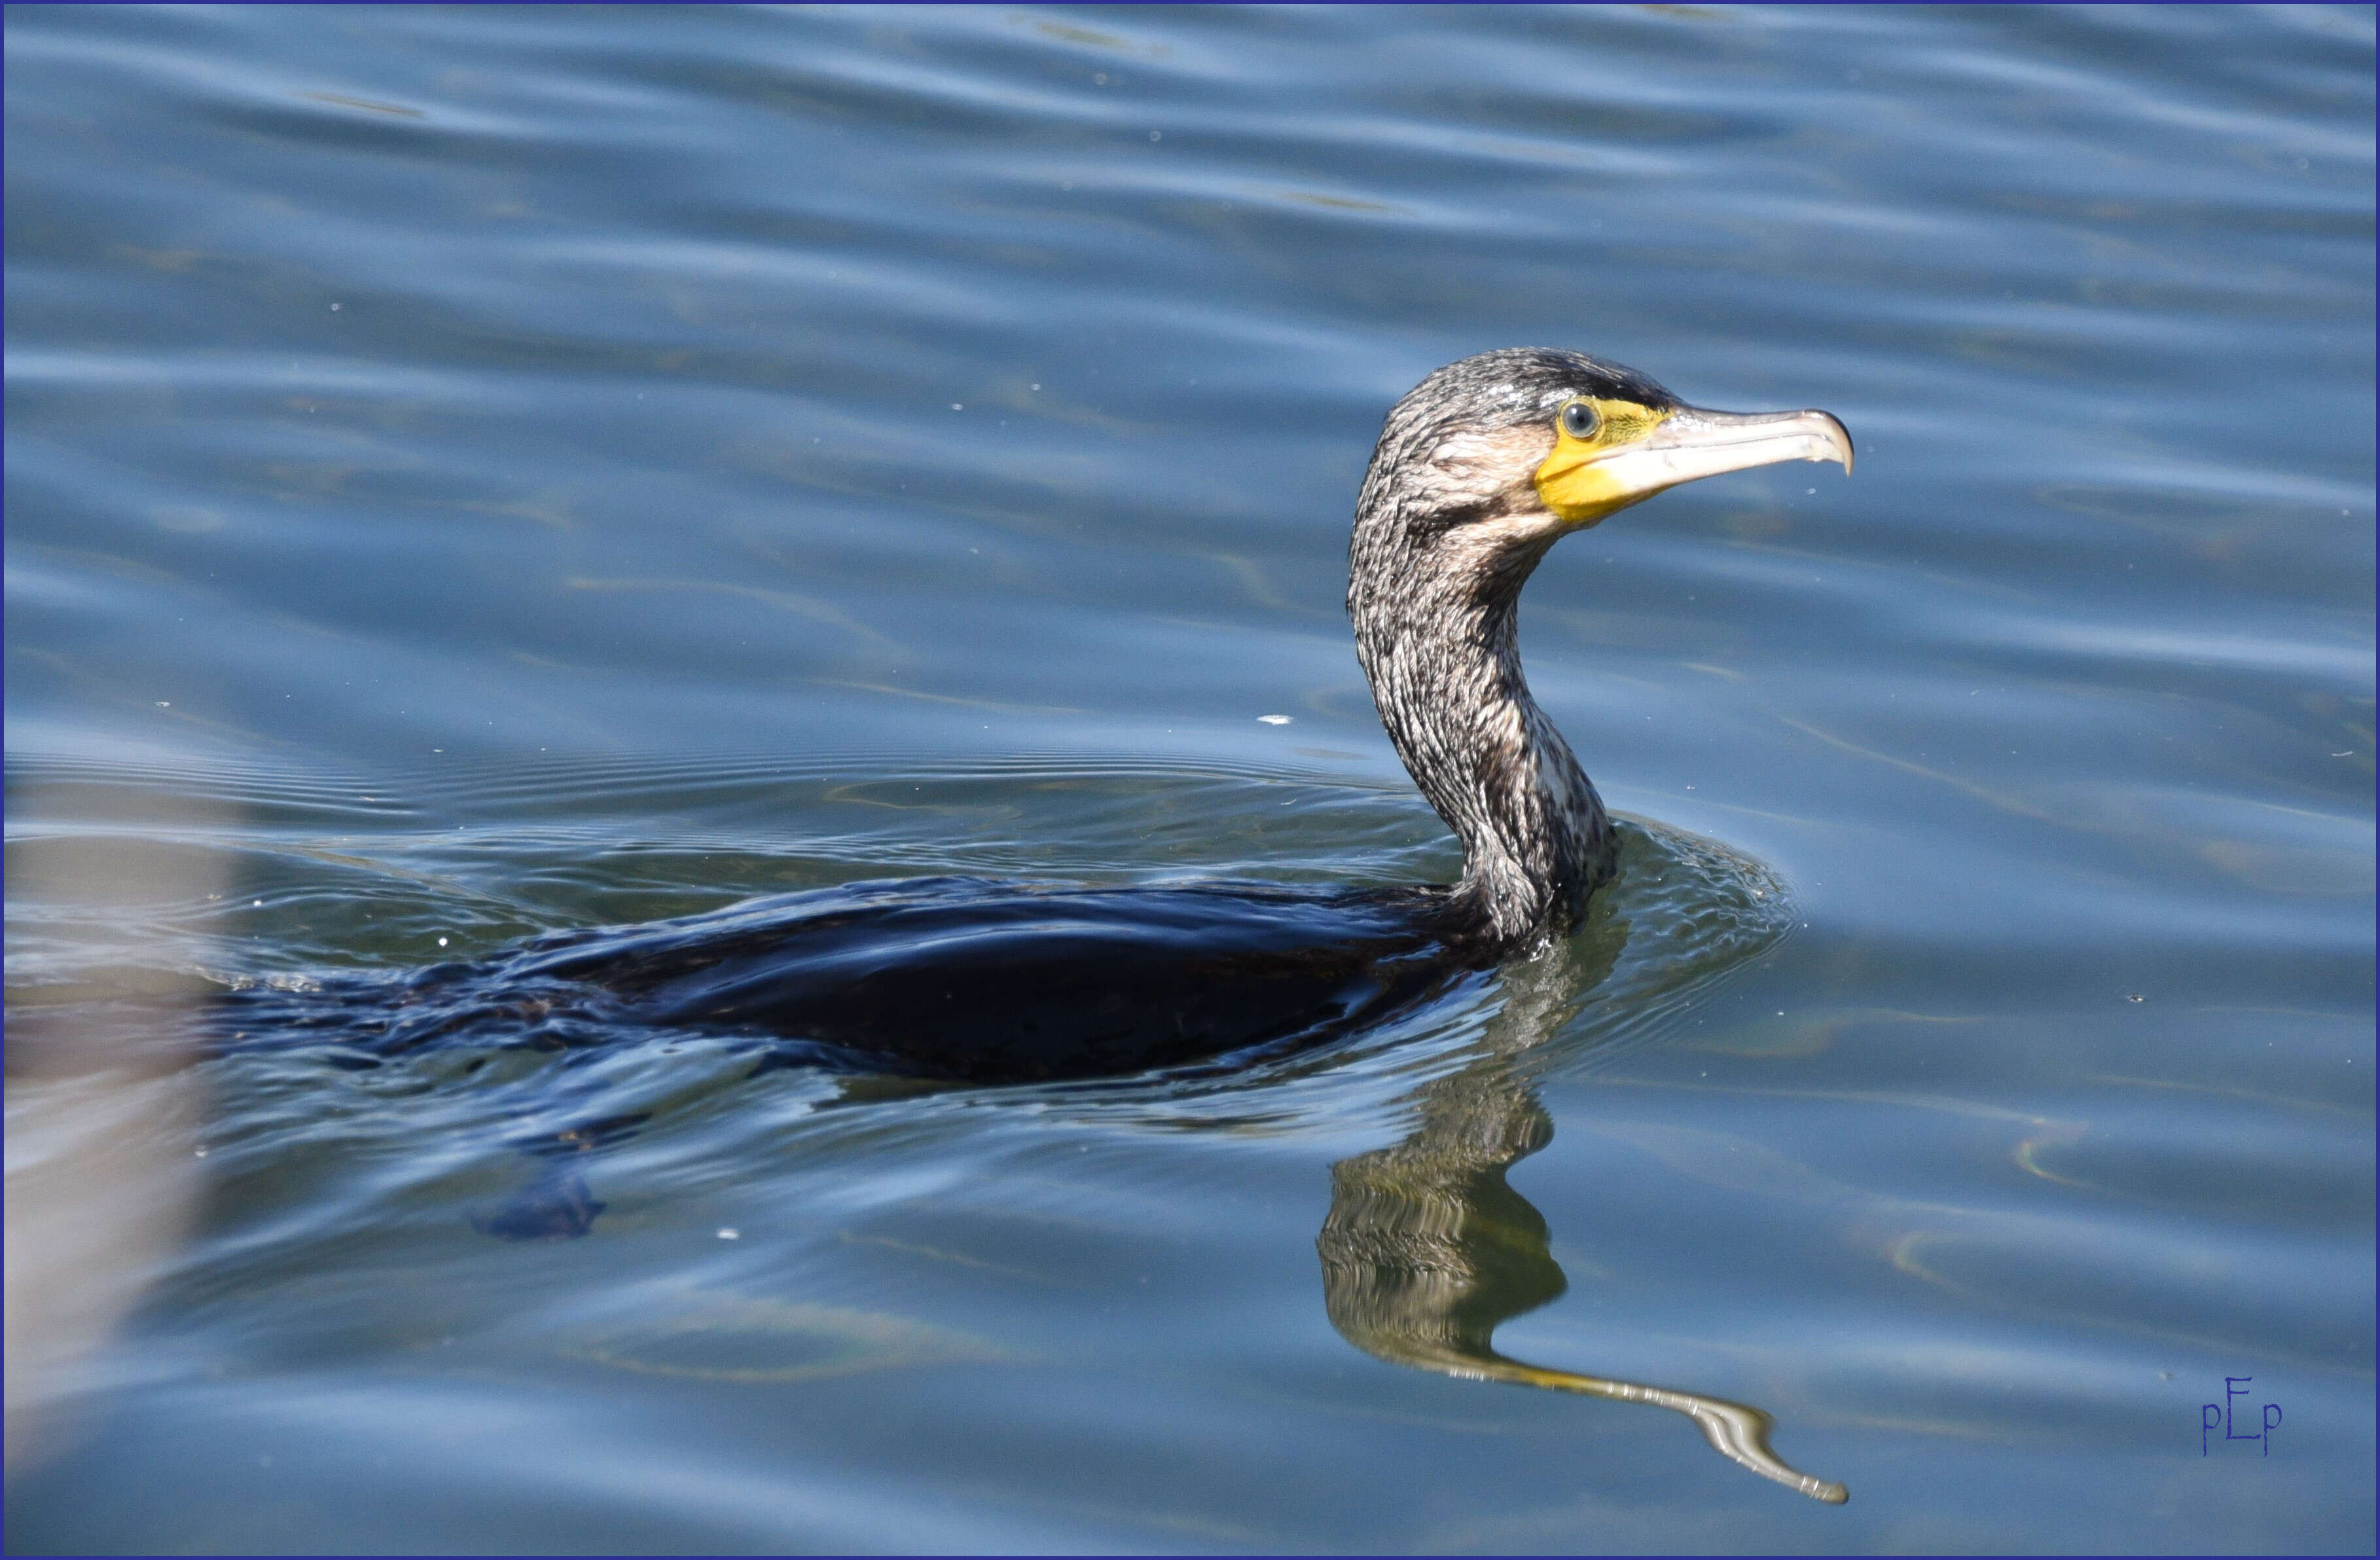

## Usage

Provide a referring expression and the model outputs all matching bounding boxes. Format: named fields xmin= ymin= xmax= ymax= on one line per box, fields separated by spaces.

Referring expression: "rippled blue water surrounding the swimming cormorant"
xmin=5 ymin=5 xmax=2375 ymax=1553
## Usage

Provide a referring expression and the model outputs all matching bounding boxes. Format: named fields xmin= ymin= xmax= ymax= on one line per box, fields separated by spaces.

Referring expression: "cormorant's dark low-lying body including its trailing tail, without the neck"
xmin=221 ymin=877 xmax=1494 ymax=1083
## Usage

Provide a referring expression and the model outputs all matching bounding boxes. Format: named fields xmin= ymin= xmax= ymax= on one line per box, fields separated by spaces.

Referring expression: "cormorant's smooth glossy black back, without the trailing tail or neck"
xmin=516 ymin=877 xmax=1462 ymax=1083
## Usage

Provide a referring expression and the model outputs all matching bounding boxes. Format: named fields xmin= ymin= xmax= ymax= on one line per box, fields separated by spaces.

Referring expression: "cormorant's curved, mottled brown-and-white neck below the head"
xmin=1350 ymin=557 xmax=1618 ymax=945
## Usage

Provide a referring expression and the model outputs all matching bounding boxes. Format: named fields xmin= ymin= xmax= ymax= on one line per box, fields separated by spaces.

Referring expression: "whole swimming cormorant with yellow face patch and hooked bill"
xmin=223 ymin=348 xmax=1852 ymax=1083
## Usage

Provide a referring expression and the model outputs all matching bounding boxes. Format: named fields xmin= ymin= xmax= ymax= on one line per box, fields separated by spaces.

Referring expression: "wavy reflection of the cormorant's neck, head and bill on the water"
xmin=1316 ymin=943 xmax=1849 ymax=1505
